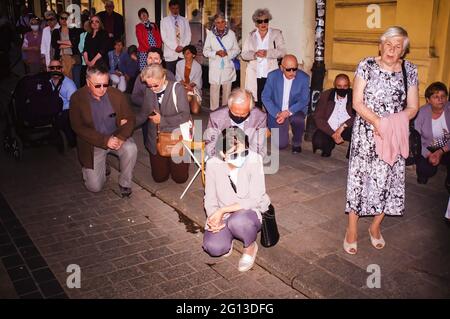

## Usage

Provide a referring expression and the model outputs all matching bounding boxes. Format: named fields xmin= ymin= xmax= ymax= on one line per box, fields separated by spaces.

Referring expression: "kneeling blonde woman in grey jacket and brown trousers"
xmin=136 ymin=64 xmax=190 ymax=183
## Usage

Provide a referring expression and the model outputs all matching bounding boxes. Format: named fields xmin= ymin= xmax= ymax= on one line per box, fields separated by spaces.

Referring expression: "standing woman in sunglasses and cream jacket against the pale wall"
xmin=241 ymin=9 xmax=286 ymax=108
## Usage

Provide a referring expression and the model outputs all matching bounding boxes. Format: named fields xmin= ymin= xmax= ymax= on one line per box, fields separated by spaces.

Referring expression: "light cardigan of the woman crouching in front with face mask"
xmin=205 ymin=151 xmax=270 ymax=221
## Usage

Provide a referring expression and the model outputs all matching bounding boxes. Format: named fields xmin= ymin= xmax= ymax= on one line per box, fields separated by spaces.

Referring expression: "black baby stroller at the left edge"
xmin=3 ymin=72 xmax=66 ymax=160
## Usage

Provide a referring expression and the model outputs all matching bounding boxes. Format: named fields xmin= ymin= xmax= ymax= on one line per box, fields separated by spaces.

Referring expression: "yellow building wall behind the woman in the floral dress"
xmin=324 ymin=0 xmax=450 ymax=103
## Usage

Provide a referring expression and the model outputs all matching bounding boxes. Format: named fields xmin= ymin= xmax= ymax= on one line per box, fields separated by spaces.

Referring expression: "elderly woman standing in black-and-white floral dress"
xmin=344 ymin=27 xmax=419 ymax=255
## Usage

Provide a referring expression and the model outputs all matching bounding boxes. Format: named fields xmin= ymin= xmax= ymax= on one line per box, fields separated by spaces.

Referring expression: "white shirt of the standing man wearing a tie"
xmin=161 ymin=15 xmax=191 ymax=62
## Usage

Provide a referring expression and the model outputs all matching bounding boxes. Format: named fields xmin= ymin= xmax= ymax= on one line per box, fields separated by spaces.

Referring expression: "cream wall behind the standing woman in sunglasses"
xmin=242 ymin=0 xmax=315 ymax=73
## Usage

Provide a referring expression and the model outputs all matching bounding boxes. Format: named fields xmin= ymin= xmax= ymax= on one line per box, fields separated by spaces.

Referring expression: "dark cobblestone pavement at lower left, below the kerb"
xmin=0 ymin=146 xmax=305 ymax=298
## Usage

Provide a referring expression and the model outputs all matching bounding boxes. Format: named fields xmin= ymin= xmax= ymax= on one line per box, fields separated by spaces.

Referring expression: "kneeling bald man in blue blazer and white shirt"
xmin=262 ymin=54 xmax=309 ymax=154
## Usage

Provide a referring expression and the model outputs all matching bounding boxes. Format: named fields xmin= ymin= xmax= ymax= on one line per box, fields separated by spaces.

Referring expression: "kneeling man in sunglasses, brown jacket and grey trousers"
xmin=70 ymin=64 xmax=137 ymax=197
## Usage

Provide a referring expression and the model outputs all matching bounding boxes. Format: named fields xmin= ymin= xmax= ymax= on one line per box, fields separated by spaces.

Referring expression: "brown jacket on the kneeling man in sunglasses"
xmin=69 ymin=86 xmax=136 ymax=169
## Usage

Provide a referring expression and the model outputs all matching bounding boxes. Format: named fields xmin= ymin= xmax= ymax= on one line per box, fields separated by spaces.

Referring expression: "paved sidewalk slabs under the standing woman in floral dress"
xmin=108 ymin=113 xmax=450 ymax=298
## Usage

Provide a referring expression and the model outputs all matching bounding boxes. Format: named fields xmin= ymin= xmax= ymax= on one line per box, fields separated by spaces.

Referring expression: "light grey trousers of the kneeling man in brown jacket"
xmin=81 ymin=137 xmax=137 ymax=193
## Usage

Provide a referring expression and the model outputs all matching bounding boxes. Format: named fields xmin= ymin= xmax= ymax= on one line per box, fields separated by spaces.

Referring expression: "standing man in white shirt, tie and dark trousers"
xmin=161 ymin=0 xmax=191 ymax=74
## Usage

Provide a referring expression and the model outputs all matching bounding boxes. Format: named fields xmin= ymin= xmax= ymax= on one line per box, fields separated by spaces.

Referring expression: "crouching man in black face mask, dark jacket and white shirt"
xmin=312 ymin=74 xmax=355 ymax=158
